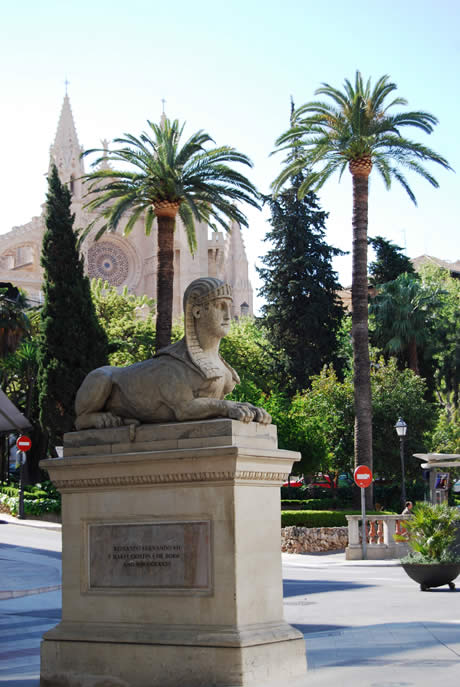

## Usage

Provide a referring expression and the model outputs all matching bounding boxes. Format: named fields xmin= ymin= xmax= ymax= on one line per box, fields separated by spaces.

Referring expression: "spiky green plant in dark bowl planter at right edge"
xmin=395 ymin=503 xmax=460 ymax=591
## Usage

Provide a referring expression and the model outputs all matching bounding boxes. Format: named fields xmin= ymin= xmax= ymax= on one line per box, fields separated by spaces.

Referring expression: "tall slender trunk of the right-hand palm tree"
xmin=351 ymin=170 xmax=373 ymax=506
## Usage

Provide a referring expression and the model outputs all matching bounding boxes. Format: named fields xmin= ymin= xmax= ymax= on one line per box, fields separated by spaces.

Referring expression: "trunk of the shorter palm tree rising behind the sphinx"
xmin=155 ymin=213 xmax=176 ymax=351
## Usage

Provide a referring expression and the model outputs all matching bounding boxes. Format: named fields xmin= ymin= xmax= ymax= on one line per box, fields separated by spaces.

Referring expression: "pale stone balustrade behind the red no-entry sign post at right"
xmin=345 ymin=515 xmax=411 ymax=560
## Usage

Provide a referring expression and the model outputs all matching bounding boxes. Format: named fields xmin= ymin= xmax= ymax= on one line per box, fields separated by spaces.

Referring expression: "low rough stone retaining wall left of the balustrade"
xmin=281 ymin=526 xmax=348 ymax=553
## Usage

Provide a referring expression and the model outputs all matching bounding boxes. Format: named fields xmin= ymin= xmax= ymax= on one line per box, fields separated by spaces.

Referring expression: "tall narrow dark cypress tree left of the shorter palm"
xmin=38 ymin=165 xmax=107 ymax=447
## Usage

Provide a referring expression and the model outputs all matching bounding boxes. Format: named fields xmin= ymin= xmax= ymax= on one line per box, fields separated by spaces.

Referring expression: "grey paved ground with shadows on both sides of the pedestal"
xmin=0 ymin=514 xmax=460 ymax=687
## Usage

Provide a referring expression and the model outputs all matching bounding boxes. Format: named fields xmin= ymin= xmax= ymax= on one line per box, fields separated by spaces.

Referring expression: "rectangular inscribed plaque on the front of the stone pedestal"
xmin=88 ymin=521 xmax=210 ymax=590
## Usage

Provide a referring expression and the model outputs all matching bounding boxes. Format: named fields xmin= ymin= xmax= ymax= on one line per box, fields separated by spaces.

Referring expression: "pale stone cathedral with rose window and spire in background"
xmin=0 ymin=94 xmax=253 ymax=319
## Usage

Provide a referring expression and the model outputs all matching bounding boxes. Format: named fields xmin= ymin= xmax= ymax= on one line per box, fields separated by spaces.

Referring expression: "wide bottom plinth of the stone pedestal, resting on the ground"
xmin=40 ymin=637 xmax=306 ymax=687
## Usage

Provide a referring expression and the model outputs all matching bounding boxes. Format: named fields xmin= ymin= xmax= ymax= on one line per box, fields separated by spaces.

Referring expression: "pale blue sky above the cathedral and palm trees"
xmin=0 ymin=0 xmax=460 ymax=310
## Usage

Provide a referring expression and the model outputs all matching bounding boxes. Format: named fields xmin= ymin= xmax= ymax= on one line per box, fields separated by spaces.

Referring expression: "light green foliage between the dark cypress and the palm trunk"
xmin=91 ymin=279 xmax=155 ymax=365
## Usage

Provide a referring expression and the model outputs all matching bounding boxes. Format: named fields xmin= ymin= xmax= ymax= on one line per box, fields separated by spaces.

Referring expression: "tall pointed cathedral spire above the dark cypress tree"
xmin=50 ymin=91 xmax=85 ymax=200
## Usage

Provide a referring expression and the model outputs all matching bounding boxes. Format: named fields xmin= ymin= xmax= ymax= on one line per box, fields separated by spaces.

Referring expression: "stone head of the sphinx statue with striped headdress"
xmin=184 ymin=277 xmax=233 ymax=378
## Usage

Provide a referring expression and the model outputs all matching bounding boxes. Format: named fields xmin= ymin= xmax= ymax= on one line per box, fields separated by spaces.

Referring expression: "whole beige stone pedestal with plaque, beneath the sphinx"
xmin=41 ymin=419 xmax=306 ymax=687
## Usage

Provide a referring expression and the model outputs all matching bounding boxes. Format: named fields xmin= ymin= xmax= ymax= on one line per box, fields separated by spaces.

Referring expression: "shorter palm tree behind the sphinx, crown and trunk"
xmin=85 ymin=117 xmax=259 ymax=350
